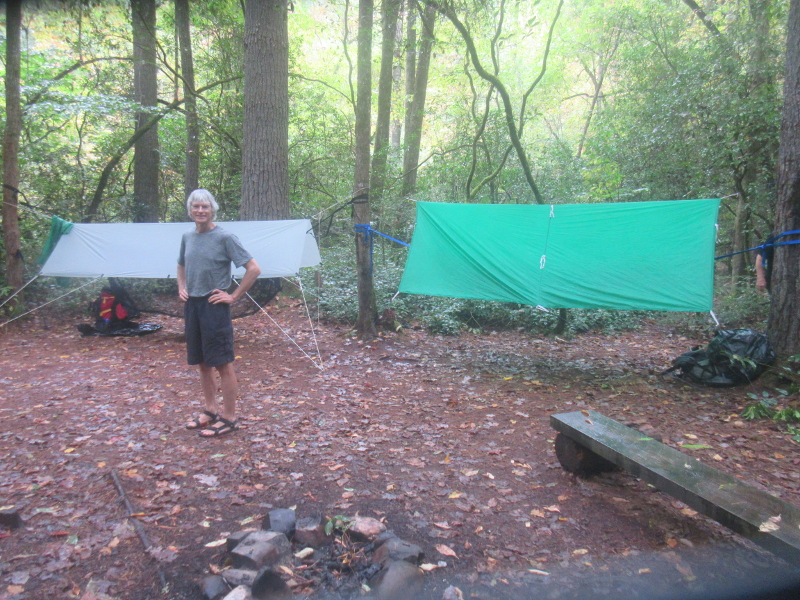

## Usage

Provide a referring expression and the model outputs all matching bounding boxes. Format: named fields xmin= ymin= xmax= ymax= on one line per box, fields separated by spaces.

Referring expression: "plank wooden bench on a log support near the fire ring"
xmin=550 ymin=410 xmax=800 ymax=564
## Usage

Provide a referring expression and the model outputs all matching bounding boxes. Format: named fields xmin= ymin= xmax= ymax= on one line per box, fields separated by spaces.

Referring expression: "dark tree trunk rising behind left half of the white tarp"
xmin=131 ymin=0 xmax=161 ymax=223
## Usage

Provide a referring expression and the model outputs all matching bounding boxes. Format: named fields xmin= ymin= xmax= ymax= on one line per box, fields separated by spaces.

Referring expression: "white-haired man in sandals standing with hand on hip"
xmin=178 ymin=189 xmax=261 ymax=437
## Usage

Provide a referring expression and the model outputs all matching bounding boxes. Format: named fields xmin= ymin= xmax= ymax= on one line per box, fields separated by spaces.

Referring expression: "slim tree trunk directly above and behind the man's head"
xmin=175 ymin=0 xmax=200 ymax=206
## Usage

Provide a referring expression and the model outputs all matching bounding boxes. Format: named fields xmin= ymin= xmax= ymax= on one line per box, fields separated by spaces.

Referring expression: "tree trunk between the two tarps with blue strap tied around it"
xmin=353 ymin=0 xmax=378 ymax=339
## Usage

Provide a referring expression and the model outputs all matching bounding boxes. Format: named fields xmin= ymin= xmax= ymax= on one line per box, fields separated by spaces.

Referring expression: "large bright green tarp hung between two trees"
xmin=400 ymin=200 xmax=719 ymax=312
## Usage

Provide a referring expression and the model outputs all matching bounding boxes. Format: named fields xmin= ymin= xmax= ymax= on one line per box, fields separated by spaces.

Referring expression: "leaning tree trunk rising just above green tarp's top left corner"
xmin=402 ymin=6 xmax=436 ymax=197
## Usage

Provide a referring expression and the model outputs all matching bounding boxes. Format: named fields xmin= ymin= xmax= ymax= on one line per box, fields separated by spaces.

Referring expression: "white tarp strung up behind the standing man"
xmin=40 ymin=219 xmax=320 ymax=279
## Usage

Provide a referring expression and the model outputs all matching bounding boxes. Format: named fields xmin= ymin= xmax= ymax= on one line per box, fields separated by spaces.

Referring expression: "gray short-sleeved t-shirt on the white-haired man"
xmin=178 ymin=225 xmax=253 ymax=296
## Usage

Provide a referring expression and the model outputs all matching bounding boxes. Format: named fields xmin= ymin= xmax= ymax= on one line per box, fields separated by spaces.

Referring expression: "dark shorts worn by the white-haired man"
xmin=183 ymin=296 xmax=236 ymax=367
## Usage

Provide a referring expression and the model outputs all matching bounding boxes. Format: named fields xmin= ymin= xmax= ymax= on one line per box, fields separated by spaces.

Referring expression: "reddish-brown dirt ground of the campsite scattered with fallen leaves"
xmin=0 ymin=299 xmax=800 ymax=600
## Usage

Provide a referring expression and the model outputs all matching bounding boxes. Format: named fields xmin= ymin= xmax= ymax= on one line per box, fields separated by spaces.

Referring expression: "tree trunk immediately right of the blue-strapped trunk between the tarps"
xmin=370 ymin=0 xmax=400 ymax=223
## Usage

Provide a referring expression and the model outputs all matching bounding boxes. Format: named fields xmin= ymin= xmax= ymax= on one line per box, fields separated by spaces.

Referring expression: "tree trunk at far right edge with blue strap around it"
xmin=768 ymin=0 xmax=800 ymax=356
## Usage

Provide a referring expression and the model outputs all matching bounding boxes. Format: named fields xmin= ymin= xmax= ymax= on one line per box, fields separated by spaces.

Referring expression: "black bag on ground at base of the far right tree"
xmin=662 ymin=329 xmax=776 ymax=387
